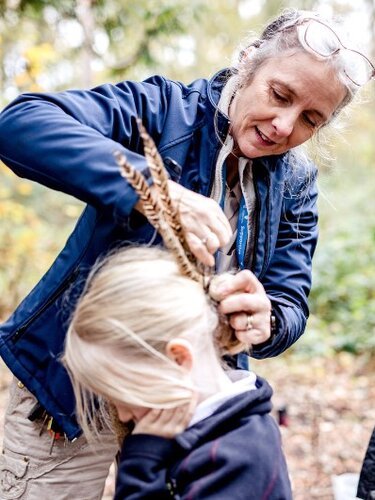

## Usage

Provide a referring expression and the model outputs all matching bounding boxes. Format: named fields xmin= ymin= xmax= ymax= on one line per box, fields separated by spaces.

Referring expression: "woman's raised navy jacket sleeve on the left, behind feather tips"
xmin=0 ymin=77 xmax=170 ymax=225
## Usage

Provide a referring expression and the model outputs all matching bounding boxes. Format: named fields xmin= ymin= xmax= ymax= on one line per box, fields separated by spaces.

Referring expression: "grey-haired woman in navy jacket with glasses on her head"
xmin=0 ymin=7 xmax=374 ymax=499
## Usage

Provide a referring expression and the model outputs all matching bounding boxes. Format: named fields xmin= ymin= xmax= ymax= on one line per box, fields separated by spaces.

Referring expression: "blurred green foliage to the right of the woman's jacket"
xmin=295 ymin=106 xmax=375 ymax=354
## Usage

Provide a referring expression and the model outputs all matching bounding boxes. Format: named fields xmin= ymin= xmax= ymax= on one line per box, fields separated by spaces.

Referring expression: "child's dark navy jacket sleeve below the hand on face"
xmin=114 ymin=434 xmax=175 ymax=500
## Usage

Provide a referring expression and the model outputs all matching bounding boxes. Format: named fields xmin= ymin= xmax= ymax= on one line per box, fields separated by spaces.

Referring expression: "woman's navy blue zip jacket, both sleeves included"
xmin=0 ymin=71 xmax=317 ymax=439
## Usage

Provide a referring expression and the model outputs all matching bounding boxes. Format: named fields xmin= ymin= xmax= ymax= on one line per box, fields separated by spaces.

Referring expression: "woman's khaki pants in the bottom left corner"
xmin=0 ymin=380 xmax=118 ymax=500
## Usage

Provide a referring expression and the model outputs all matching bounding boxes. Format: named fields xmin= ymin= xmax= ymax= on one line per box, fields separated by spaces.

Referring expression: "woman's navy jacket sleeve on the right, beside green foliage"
xmin=252 ymin=167 xmax=318 ymax=358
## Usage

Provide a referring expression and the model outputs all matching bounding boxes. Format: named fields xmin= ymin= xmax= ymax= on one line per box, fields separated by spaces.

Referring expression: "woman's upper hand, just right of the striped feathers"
xmin=135 ymin=180 xmax=232 ymax=266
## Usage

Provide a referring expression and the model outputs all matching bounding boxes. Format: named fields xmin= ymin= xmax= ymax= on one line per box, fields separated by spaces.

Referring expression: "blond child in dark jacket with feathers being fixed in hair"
xmin=64 ymin=247 xmax=292 ymax=500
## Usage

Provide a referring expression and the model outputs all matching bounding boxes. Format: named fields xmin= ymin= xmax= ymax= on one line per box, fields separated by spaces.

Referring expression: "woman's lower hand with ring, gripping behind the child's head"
xmin=217 ymin=269 xmax=271 ymax=346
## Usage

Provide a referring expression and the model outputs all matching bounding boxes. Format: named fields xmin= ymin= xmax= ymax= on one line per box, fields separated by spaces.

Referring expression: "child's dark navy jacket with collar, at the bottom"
xmin=115 ymin=378 xmax=292 ymax=500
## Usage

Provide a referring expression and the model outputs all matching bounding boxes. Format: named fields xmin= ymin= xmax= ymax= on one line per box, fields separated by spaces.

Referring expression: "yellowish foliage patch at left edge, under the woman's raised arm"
xmin=0 ymin=163 xmax=81 ymax=320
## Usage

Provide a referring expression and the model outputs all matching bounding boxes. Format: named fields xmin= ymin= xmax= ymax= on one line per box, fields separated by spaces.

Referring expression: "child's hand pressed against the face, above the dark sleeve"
xmin=133 ymin=401 xmax=196 ymax=439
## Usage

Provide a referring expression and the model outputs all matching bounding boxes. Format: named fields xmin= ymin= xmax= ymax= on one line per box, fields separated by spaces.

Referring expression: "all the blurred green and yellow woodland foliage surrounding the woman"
xmin=0 ymin=0 xmax=375 ymax=351
